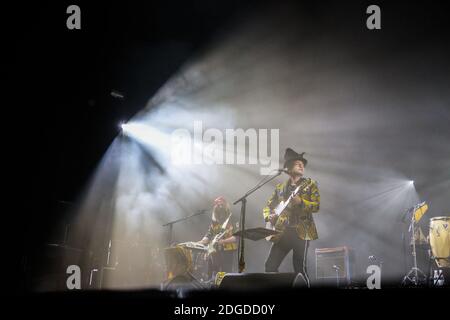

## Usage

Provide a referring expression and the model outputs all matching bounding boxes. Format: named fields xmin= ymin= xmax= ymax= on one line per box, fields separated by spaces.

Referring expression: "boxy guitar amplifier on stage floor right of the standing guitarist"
xmin=316 ymin=246 xmax=353 ymax=286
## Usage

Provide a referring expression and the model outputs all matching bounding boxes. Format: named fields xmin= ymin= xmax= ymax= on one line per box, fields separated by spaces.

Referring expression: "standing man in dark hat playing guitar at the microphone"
xmin=263 ymin=148 xmax=320 ymax=282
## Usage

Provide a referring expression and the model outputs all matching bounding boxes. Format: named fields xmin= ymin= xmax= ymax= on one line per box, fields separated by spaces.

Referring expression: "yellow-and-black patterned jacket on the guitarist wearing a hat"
xmin=263 ymin=178 xmax=320 ymax=242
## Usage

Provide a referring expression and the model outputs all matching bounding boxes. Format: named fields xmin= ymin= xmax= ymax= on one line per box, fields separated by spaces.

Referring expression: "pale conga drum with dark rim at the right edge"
xmin=429 ymin=217 xmax=450 ymax=268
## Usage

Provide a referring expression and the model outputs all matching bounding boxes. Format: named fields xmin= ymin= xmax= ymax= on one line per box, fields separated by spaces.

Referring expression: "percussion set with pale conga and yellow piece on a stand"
xmin=402 ymin=202 xmax=450 ymax=286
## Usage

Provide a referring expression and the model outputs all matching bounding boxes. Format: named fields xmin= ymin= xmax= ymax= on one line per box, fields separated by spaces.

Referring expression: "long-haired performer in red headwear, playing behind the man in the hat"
xmin=200 ymin=197 xmax=237 ymax=278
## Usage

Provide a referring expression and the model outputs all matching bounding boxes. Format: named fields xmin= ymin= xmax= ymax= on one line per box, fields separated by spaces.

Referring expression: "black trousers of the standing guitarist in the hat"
xmin=265 ymin=227 xmax=308 ymax=277
